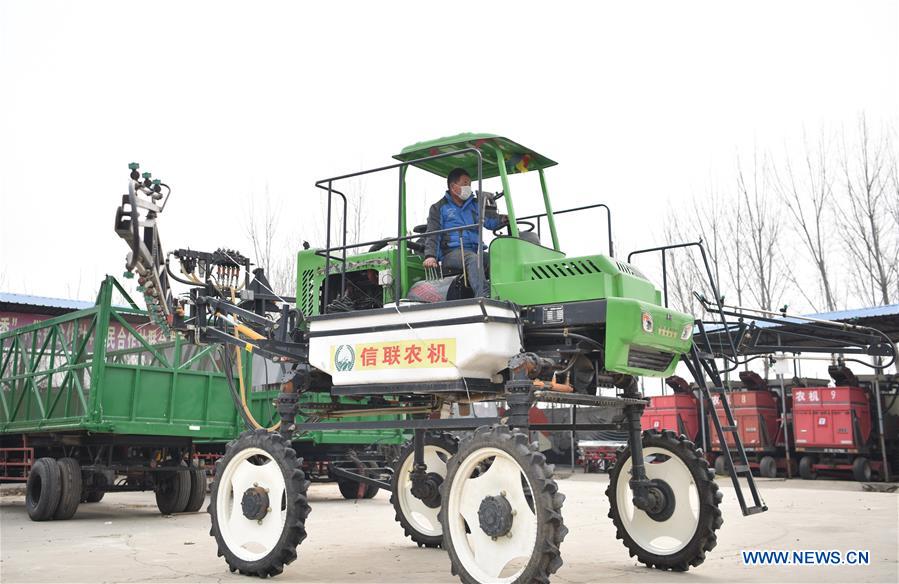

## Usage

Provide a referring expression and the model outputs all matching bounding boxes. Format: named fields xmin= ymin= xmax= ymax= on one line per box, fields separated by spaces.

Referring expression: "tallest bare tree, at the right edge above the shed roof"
xmin=837 ymin=116 xmax=899 ymax=305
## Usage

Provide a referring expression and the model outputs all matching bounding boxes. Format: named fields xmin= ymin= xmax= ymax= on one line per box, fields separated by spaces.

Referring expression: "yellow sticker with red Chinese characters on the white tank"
xmin=331 ymin=339 xmax=456 ymax=371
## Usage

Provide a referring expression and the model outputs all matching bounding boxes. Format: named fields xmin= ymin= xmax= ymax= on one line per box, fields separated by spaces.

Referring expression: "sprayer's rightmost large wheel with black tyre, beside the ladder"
xmin=606 ymin=430 xmax=723 ymax=572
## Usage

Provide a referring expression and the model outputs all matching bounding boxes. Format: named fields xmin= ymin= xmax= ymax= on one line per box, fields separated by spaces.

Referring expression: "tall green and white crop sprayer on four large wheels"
xmin=1 ymin=134 xmax=893 ymax=583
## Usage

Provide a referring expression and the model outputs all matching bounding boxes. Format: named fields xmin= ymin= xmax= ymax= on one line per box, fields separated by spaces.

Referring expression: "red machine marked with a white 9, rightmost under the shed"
xmin=793 ymin=368 xmax=883 ymax=481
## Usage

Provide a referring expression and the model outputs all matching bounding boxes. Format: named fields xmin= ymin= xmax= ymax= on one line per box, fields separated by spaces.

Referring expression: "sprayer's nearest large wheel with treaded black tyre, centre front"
xmin=440 ymin=426 xmax=568 ymax=584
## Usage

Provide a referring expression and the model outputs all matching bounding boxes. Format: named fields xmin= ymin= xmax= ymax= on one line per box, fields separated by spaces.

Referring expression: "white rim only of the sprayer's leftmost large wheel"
xmin=215 ymin=448 xmax=287 ymax=562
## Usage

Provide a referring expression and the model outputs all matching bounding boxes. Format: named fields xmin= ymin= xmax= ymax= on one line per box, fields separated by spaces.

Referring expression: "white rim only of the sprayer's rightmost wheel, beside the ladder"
xmin=615 ymin=446 xmax=700 ymax=556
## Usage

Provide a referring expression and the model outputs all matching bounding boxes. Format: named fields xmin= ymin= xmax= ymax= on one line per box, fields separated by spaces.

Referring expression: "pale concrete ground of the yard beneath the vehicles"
xmin=0 ymin=472 xmax=899 ymax=584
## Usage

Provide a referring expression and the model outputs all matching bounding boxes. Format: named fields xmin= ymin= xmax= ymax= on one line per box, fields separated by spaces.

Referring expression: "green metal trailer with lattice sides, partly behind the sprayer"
xmin=0 ymin=277 xmax=406 ymax=521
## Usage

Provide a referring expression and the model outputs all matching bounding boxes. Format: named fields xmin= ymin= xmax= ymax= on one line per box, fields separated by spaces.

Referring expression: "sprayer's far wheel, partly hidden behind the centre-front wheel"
xmin=390 ymin=434 xmax=459 ymax=548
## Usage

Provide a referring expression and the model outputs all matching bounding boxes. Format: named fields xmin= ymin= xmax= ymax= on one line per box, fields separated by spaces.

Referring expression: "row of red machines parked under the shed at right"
xmin=642 ymin=365 xmax=899 ymax=481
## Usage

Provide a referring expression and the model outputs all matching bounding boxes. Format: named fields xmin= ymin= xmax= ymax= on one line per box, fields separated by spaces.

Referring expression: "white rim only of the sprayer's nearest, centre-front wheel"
xmin=443 ymin=448 xmax=537 ymax=583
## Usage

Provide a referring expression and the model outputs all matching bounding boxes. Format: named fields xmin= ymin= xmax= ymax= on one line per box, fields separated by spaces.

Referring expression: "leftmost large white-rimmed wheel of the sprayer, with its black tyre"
xmin=208 ymin=429 xmax=309 ymax=578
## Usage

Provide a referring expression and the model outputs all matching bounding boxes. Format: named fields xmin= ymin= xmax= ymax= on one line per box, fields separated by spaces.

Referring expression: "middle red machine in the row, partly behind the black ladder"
xmin=709 ymin=371 xmax=786 ymax=478
